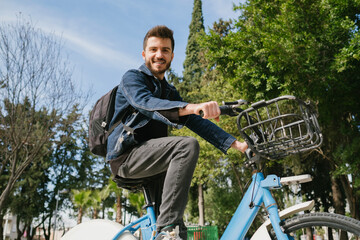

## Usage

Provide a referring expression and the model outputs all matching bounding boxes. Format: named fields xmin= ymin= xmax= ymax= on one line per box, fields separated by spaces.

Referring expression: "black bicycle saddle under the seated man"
xmin=112 ymin=173 xmax=165 ymax=192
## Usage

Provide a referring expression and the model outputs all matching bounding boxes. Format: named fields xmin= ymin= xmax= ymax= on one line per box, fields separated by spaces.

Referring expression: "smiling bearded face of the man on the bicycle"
xmin=142 ymin=37 xmax=174 ymax=79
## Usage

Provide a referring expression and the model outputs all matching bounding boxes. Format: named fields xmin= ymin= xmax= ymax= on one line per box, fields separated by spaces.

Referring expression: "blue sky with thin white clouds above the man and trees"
xmin=0 ymin=0 xmax=239 ymax=105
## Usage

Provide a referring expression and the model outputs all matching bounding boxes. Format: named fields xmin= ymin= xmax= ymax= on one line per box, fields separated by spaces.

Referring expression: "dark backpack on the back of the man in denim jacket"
xmin=89 ymin=86 xmax=121 ymax=157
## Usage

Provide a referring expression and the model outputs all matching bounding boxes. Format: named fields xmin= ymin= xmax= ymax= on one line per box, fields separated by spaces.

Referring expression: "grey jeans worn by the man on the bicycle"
xmin=118 ymin=137 xmax=199 ymax=239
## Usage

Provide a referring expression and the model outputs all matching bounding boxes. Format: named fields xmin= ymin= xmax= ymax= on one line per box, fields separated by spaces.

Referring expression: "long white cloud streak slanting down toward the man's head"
xmin=0 ymin=0 xmax=141 ymax=69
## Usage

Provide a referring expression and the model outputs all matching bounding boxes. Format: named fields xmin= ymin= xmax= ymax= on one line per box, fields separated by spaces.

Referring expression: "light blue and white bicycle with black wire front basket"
xmin=62 ymin=95 xmax=360 ymax=240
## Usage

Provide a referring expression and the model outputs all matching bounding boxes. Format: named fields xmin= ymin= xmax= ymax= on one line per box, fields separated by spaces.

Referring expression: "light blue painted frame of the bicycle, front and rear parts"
xmin=113 ymin=172 xmax=289 ymax=240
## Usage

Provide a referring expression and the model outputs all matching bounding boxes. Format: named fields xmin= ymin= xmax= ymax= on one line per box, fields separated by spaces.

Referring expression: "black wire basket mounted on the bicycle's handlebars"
xmin=237 ymin=95 xmax=322 ymax=160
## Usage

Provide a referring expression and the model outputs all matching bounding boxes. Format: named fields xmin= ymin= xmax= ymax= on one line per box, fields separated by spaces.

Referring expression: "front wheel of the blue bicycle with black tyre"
xmin=273 ymin=212 xmax=360 ymax=240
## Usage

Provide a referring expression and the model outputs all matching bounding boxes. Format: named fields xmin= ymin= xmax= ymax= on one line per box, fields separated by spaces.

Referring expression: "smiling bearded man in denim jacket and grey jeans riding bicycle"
xmin=107 ymin=26 xmax=247 ymax=239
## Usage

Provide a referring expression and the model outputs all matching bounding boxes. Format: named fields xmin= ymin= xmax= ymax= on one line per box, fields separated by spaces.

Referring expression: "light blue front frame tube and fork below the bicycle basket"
xmin=221 ymin=172 xmax=289 ymax=240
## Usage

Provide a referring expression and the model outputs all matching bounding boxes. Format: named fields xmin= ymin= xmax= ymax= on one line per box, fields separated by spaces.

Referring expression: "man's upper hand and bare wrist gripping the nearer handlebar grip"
xmin=179 ymin=101 xmax=220 ymax=122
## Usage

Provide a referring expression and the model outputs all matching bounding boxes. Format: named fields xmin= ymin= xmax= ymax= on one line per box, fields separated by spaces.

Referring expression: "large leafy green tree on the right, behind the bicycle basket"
xmin=204 ymin=0 xmax=360 ymax=218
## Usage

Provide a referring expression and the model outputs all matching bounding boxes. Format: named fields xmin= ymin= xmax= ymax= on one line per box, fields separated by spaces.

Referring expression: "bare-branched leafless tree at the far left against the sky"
xmin=0 ymin=16 xmax=86 ymax=212
